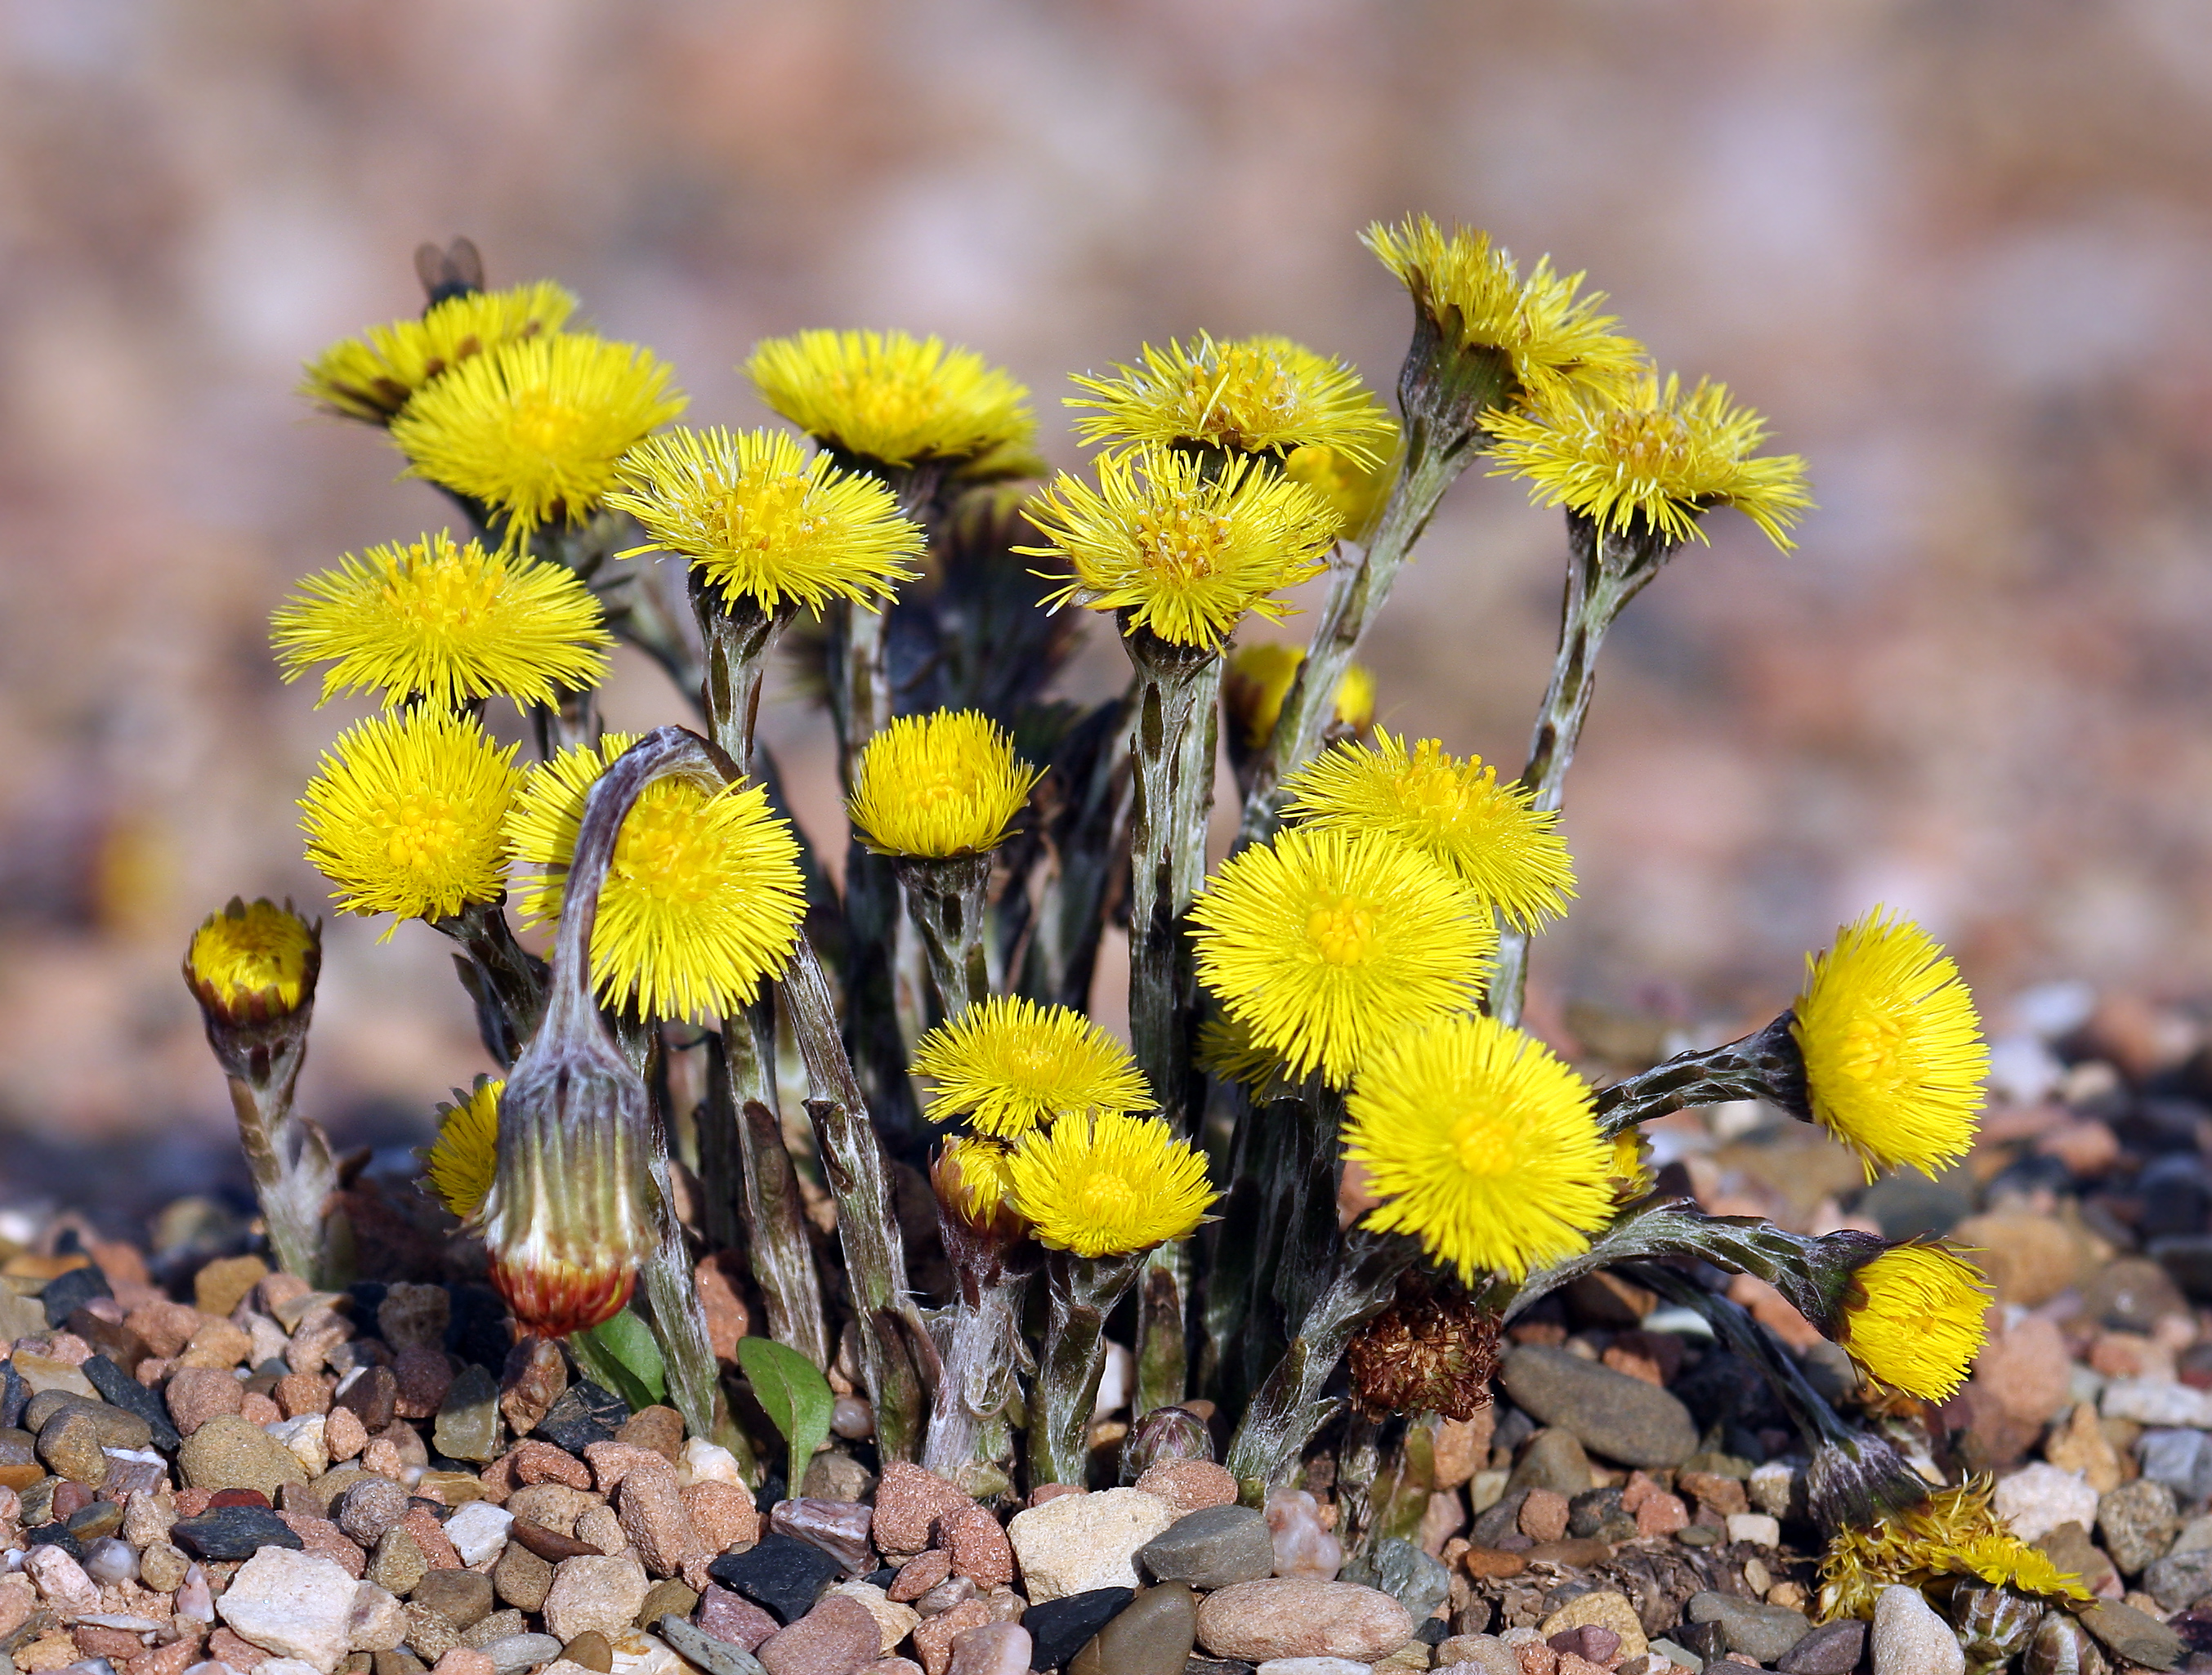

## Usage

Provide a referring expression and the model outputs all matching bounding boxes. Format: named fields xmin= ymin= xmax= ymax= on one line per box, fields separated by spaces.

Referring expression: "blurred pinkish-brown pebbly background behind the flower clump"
xmin=0 ymin=0 xmax=2212 ymax=1201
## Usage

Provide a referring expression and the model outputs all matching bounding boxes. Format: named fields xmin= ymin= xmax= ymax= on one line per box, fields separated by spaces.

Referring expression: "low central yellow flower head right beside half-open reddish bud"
xmin=1007 ymin=1110 xmax=1214 ymax=1257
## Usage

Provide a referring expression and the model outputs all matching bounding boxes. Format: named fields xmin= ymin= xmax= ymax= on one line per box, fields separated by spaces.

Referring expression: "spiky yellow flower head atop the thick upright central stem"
xmin=1016 ymin=449 xmax=1336 ymax=648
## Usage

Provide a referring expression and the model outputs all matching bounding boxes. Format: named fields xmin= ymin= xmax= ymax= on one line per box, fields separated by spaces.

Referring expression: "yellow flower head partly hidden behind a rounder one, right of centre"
xmin=1283 ymin=732 xmax=1575 ymax=929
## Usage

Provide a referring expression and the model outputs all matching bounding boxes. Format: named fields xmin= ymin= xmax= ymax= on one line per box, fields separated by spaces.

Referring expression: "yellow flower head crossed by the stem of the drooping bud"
xmin=509 ymin=732 xmax=805 ymax=1018
